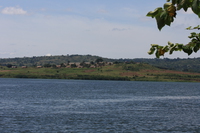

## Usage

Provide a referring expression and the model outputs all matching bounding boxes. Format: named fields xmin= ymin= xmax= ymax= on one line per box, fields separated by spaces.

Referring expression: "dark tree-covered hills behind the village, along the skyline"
xmin=0 ymin=55 xmax=200 ymax=73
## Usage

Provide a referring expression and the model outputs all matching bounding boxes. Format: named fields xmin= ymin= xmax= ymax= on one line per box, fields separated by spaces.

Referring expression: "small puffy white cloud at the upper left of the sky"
xmin=1 ymin=7 xmax=27 ymax=15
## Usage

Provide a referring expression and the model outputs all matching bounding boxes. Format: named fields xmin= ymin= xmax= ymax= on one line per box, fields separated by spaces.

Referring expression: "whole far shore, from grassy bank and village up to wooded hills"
xmin=0 ymin=55 xmax=200 ymax=81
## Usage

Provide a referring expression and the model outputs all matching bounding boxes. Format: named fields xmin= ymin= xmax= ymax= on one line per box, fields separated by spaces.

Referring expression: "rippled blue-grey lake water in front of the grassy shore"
xmin=0 ymin=78 xmax=200 ymax=133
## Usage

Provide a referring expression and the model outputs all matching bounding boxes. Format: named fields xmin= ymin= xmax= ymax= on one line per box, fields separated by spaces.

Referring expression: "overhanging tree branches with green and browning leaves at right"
xmin=147 ymin=0 xmax=200 ymax=58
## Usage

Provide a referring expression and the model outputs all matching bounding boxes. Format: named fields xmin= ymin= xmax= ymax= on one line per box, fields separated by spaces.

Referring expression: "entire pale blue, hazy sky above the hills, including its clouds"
xmin=0 ymin=0 xmax=200 ymax=59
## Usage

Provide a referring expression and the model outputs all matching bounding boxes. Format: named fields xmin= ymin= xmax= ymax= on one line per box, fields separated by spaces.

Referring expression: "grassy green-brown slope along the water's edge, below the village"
xmin=0 ymin=62 xmax=200 ymax=82
